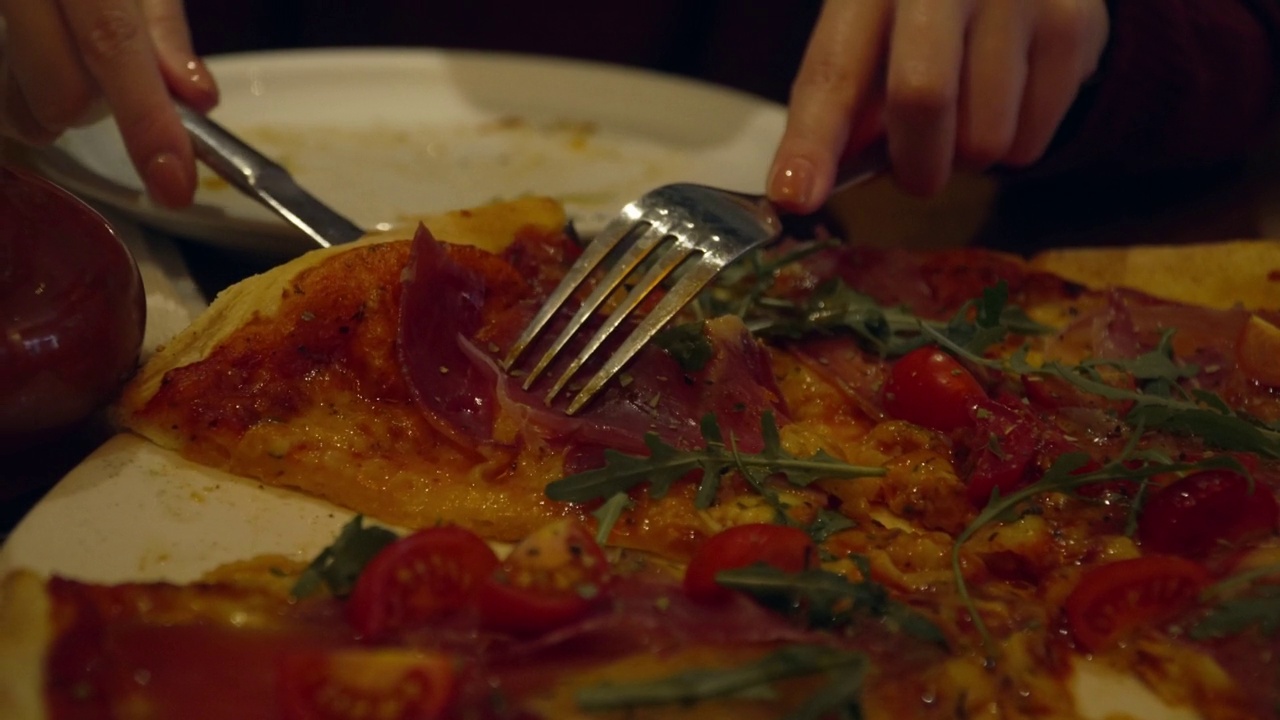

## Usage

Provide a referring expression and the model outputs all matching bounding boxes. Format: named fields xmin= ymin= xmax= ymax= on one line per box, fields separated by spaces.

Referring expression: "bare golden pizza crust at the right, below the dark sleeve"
xmin=1030 ymin=240 xmax=1280 ymax=310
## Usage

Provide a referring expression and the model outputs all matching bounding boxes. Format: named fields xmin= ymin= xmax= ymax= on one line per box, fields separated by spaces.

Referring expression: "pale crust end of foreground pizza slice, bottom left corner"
xmin=0 ymin=570 xmax=52 ymax=720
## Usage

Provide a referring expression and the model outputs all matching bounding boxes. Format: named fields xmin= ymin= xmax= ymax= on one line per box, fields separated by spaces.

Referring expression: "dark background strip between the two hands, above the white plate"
xmin=187 ymin=0 xmax=820 ymax=101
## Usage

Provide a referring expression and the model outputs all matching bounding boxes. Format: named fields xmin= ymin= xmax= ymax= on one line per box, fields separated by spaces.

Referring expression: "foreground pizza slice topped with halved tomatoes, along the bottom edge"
xmin=0 ymin=509 xmax=962 ymax=720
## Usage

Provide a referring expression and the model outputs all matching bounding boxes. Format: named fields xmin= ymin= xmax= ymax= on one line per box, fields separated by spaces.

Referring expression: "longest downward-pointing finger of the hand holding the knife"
xmin=63 ymin=0 xmax=196 ymax=208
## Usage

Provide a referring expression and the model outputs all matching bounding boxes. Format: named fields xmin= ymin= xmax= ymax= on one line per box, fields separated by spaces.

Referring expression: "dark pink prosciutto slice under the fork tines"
xmin=398 ymin=227 xmax=785 ymax=452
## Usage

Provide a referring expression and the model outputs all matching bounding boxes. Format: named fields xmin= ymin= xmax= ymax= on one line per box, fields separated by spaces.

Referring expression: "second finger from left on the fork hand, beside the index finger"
xmin=884 ymin=0 xmax=973 ymax=195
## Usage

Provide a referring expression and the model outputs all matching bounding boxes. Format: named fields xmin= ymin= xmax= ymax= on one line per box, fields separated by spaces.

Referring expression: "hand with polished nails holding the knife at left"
xmin=0 ymin=0 xmax=218 ymax=208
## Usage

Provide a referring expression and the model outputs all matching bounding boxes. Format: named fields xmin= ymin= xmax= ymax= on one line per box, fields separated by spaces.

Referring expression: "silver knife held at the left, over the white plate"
xmin=178 ymin=102 xmax=365 ymax=247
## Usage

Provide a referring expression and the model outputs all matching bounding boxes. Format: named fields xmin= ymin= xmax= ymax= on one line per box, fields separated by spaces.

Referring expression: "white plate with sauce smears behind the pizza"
xmin=33 ymin=49 xmax=785 ymax=255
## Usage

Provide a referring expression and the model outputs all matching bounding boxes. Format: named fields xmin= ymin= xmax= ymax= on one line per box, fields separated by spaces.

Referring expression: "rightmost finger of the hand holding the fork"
xmin=1005 ymin=0 xmax=1107 ymax=165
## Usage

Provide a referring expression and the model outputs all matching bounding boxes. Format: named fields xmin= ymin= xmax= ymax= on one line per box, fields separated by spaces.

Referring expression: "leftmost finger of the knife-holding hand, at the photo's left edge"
xmin=0 ymin=0 xmax=97 ymax=133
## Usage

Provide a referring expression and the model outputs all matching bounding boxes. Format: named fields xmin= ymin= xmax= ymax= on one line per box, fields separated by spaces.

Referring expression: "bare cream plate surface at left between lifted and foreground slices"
xmin=0 ymin=434 xmax=352 ymax=583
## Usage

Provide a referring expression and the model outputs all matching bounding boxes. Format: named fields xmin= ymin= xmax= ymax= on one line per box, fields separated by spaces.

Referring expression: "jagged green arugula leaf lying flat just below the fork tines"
xmin=547 ymin=414 xmax=886 ymax=507
